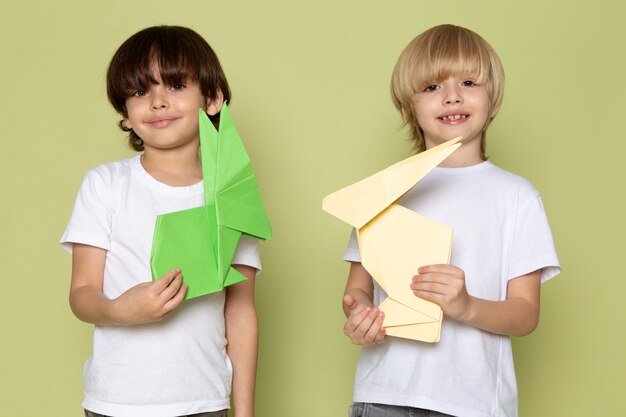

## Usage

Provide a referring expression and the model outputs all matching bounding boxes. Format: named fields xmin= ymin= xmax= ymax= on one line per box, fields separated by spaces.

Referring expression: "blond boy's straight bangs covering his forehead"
xmin=407 ymin=32 xmax=490 ymax=93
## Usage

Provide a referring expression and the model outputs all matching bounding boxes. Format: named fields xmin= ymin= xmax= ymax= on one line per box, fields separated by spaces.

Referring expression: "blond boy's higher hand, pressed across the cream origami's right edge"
xmin=411 ymin=264 xmax=470 ymax=321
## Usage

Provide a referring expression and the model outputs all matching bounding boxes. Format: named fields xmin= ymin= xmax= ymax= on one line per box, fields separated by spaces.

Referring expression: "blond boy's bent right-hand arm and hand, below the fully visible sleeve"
xmin=411 ymin=265 xmax=541 ymax=336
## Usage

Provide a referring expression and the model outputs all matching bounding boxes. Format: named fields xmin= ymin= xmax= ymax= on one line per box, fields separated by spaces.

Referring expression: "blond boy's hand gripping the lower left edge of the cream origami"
xmin=343 ymin=294 xmax=385 ymax=347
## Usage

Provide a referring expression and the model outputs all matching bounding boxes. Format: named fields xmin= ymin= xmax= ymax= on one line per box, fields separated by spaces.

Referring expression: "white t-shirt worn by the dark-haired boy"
xmin=60 ymin=156 xmax=261 ymax=417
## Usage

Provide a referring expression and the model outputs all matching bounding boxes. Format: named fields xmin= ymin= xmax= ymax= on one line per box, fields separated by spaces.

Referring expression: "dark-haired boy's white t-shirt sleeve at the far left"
xmin=59 ymin=170 xmax=111 ymax=253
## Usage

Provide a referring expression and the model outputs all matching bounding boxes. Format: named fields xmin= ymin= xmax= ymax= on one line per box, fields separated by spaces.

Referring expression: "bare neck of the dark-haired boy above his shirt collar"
xmin=141 ymin=141 xmax=202 ymax=187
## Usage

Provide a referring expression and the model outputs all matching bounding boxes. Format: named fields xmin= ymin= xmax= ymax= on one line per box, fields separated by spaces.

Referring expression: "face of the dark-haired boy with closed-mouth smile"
xmin=124 ymin=71 xmax=222 ymax=152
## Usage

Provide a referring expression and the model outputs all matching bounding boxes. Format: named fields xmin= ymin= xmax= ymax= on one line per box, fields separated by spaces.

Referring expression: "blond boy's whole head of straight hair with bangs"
xmin=391 ymin=25 xmax=504 ymax=154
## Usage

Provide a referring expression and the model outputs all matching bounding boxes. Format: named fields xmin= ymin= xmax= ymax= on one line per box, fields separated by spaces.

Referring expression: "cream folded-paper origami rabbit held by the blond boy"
xmin=322 ymin=138 xmax=461 ymax=343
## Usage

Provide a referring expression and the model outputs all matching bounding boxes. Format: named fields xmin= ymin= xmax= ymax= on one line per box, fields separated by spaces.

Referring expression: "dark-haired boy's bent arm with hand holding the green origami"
xmin=70 ymin=243 xmax=187 ymax=326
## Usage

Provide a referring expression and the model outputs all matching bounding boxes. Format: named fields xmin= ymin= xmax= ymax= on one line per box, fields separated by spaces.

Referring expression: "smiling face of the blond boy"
xmin=413 ymin=75 xmax=496 ymax=155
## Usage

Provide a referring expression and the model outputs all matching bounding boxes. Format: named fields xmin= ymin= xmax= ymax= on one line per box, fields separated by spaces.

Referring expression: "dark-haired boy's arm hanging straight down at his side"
xmin=224 ymin=265 xmax=259 ymax=417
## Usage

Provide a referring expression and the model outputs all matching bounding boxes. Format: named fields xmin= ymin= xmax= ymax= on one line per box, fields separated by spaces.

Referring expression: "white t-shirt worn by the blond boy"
xmin=344 ymin=162 xmax=560 ymax=417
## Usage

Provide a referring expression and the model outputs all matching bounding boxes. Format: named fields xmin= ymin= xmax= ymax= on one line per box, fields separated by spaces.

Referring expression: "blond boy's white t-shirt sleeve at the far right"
xmin=507 ymin=194 xmax=561 ymax=283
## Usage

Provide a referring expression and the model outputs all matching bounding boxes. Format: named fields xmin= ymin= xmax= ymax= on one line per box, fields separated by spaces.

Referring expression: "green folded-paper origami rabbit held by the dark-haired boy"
xmin=150 ymin=103 xmax=272 ymax=299
